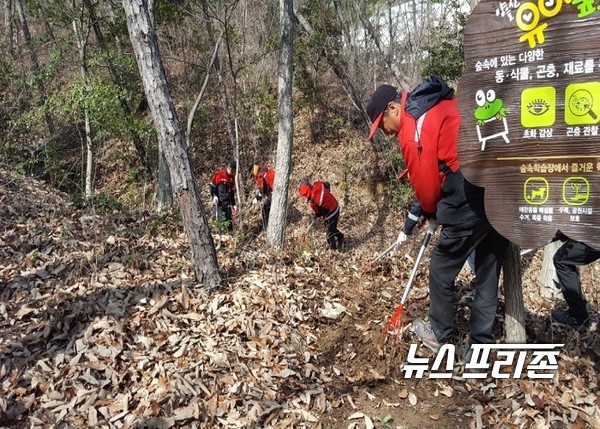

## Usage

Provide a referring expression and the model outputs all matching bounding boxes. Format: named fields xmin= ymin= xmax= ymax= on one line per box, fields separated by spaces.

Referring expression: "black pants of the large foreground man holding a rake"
xmin=429 ymin=221 xmax=508 ymax=344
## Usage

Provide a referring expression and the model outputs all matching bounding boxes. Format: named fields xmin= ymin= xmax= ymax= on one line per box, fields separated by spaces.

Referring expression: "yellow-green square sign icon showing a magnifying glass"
xmin=565 ymin=82 xmax=600 ymax=125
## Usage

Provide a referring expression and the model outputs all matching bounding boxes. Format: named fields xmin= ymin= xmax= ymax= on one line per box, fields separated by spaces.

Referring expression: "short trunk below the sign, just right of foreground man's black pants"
xmin=503 ymin=243 xmax=527 ymax=344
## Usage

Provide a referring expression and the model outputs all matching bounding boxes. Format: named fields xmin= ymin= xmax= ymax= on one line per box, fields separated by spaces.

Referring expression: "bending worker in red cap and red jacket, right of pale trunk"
xmin=298 ymin=180 xmax=344 ymax=250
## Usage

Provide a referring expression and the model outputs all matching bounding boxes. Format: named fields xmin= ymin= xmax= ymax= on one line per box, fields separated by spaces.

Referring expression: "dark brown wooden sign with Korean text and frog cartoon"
xmin=457 ymin=0 xmax=600 ymax=248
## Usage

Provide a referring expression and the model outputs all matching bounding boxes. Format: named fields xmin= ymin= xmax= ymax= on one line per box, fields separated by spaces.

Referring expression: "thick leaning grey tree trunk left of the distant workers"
xmin=123 ymin=0 xmax=221 ymax=288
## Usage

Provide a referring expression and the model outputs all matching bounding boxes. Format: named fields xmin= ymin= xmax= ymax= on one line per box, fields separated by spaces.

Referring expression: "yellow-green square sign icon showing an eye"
xmin=521 ymin=86 xmax=556 ymax=128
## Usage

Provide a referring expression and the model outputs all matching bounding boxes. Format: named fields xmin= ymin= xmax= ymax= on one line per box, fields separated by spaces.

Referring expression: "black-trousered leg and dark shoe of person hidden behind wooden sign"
xmin=551 ymin=231 xmax=600 ymax=329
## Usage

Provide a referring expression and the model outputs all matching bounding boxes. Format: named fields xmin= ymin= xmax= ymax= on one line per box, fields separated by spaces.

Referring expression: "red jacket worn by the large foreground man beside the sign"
xmin=398 ymin=92 xmax=460 ymax=215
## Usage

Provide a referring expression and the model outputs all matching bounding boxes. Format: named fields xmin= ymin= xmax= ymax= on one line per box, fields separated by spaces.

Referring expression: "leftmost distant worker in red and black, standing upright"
xmin=208 ymin=161 xmax=237 ymax=231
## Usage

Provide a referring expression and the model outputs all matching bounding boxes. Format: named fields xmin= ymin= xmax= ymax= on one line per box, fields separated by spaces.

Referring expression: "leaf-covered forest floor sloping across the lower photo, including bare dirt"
xmin=0 ymin=127 xmax=600 ymax=429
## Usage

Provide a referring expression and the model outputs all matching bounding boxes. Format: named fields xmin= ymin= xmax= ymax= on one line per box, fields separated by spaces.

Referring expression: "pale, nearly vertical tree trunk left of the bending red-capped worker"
xmin=267 ymin=0 xmax=294 ymax=248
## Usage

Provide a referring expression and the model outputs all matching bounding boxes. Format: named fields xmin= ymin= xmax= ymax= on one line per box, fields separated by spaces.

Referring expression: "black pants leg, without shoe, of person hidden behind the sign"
xmin=554 ymin=239 xmax=600 ymax=320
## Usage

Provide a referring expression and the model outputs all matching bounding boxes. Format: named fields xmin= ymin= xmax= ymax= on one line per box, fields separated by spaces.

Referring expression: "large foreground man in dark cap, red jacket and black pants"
xmin=367 ymin=76 xmax=508 ymax=359
